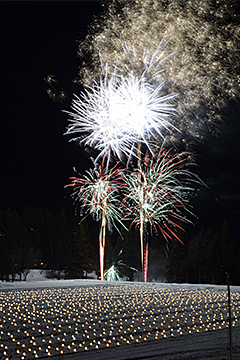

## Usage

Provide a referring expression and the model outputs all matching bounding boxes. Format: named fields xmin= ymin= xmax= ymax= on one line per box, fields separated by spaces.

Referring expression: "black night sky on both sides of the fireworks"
xmin=0 ymin=1 xmax=240 ymax=236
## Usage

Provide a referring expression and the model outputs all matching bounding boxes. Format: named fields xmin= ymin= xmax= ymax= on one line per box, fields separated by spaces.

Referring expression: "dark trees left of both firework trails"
xmin=0 ymin=206 xmax=95 ymax=281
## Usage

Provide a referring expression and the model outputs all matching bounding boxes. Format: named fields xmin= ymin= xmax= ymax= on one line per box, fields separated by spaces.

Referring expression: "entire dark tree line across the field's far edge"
xmin=0 ymin=206 xmax=240 ymax=285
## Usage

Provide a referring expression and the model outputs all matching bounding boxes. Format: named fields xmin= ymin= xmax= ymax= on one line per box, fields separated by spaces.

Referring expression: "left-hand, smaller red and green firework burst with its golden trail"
xmin=66 ymin=158 xmax=123 ymax=280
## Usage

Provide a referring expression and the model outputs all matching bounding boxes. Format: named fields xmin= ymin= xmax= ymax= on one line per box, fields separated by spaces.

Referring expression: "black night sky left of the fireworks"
xmin=0 ymin=1 xmax=100 ymax=211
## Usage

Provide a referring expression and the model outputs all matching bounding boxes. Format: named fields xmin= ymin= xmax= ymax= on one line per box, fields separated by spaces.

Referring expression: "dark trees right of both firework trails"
xmin=166 ymin=220 xmax=240 ymax=285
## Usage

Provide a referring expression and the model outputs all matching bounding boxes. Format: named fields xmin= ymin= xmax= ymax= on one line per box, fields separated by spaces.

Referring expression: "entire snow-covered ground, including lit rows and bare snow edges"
xmin=0 ymin=270 xmax=240 ymax=360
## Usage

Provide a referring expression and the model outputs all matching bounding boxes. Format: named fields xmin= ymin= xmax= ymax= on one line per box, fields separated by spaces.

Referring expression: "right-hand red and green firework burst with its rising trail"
xmin=122 ymin=149 xmax=200 ymax=281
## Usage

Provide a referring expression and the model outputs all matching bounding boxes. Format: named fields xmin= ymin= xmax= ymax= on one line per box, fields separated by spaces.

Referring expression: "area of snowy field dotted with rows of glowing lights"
xmin=0 ymin=281 xmax=240 ymax=360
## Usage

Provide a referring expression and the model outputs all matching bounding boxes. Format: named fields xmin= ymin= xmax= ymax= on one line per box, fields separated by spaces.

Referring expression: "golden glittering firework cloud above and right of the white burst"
xmin=79 ymin=0 xmax=240 ymax=139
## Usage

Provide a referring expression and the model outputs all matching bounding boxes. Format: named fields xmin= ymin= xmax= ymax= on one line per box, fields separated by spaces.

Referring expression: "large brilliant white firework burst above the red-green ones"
xmin=66 ymin=58 xmax=176 ymax=161
